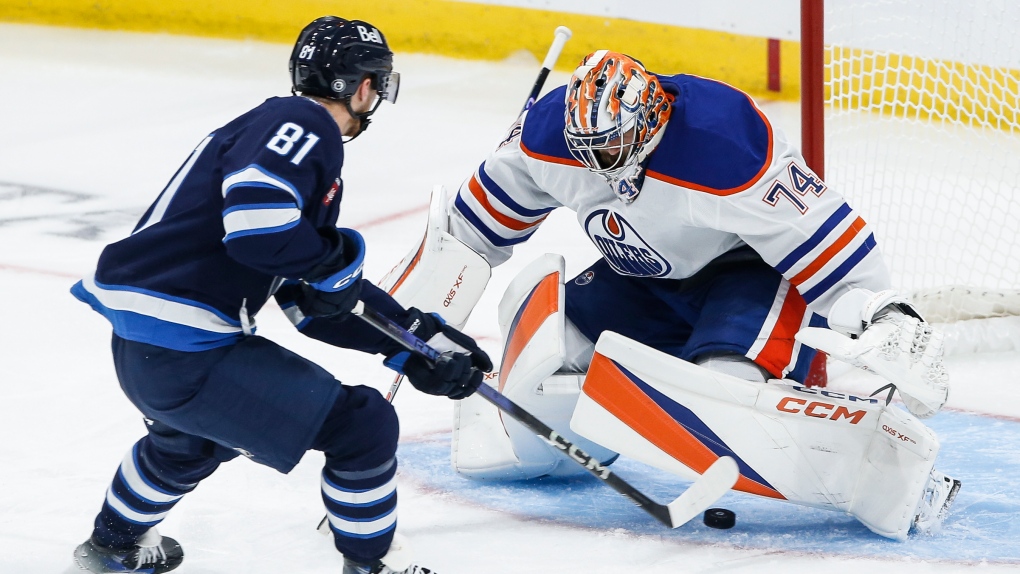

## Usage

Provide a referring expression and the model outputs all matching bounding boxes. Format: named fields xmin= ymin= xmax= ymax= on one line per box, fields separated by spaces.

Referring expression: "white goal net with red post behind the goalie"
xmin=801 ymin=0 xmax=1020 ymax=352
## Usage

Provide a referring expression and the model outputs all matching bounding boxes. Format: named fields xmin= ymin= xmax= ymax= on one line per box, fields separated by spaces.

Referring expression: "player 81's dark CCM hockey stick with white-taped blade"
xmin=353 ymin=303 xmax=740 ymax=528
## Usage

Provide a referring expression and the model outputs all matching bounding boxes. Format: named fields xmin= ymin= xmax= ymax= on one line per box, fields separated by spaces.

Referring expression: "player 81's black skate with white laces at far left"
xmin=74 ymin=528 xmax=183 ymax=574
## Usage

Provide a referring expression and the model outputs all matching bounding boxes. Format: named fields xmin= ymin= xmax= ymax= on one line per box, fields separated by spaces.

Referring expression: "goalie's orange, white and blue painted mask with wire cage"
xmin=563 ymin=50 xmax=672 ymax=203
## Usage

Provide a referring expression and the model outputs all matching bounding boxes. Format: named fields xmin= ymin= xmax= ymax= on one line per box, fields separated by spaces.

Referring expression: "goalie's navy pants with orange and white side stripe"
xmin=565 ymin=254 xmax=825 ymax=381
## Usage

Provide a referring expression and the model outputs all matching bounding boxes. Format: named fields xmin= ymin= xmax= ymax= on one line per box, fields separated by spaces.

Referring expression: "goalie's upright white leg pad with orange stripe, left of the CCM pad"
xmin=452 ymin=255 xmax=615 ymax=479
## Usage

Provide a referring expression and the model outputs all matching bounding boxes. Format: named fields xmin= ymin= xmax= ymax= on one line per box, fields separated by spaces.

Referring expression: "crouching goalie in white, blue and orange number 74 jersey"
xmin=385 ymin=50 xmax=960 ymax=539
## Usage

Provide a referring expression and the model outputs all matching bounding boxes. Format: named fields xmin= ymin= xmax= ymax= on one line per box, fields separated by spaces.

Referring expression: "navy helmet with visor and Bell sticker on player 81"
xmin=290 ymin=16 xmax=400 ymax=139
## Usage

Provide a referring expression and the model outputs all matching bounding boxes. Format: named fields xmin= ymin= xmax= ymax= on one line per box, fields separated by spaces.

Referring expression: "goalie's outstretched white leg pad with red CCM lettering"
xmin=570 ymin=332 xmax=938 ymax=539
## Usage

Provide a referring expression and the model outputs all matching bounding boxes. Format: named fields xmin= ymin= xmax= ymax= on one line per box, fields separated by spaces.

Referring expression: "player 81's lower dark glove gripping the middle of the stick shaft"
xmin=384 ymin=307 xmax=493 ymax=401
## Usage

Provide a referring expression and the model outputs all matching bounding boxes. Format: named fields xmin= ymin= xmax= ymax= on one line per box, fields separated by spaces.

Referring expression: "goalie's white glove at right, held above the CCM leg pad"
xmin=797 ymin=289 xmax=950 ymax=418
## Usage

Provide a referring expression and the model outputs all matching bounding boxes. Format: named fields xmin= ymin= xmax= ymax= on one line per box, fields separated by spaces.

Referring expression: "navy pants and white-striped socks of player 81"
xmin=93 ymin=335 xmax=399 ymax=562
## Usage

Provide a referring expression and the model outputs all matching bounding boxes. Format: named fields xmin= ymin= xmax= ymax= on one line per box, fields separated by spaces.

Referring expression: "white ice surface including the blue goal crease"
xmin=0 ymin=24 xmax=1020 ymax=574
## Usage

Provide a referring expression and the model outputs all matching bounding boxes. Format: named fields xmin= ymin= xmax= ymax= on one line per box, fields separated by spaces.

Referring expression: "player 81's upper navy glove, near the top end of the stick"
xmin=298 ymin=227 xmax=365 ymax=320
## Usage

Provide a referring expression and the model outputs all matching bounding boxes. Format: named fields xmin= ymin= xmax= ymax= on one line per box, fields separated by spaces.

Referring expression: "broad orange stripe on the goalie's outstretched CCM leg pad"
xmin=582 ymin=353 xmax=785 ymax=500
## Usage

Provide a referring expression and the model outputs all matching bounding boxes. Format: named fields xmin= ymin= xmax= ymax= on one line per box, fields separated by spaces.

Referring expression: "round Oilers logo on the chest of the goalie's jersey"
xmin=584 ymin=209 xmax=672 ymax=277
